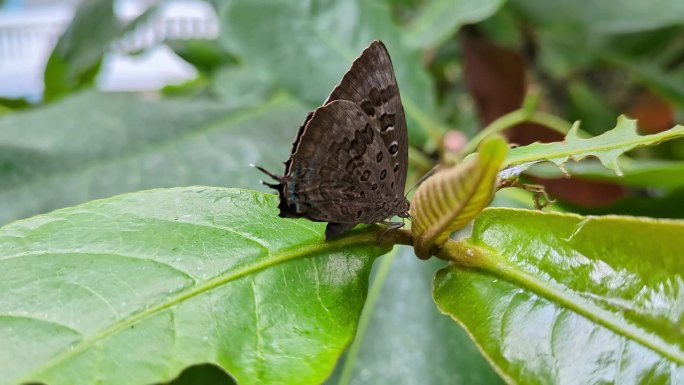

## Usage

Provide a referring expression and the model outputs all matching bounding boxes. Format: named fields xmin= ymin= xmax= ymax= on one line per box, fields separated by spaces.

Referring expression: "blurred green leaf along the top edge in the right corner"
xmin=512 ymin=0 xmax=684 ymax=33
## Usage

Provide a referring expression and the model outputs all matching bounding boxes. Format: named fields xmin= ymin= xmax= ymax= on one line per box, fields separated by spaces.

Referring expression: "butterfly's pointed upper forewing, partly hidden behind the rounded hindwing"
xmin=325 ymin=40 xmax=408 ymax=195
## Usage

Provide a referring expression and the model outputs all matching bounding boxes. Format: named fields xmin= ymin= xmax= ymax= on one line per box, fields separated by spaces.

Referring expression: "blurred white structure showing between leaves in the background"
xmin=0 ymin=0 xmax=218 ymax=100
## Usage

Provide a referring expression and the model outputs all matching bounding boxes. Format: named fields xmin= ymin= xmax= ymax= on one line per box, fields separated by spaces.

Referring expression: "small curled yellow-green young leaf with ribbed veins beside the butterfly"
xmin=411 ymin=135 xmax=508 ymax=259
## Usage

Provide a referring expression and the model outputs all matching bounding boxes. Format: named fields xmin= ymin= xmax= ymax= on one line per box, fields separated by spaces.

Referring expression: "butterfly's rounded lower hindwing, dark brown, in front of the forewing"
xmin=279 ymin=100 xmax=403 ymax=224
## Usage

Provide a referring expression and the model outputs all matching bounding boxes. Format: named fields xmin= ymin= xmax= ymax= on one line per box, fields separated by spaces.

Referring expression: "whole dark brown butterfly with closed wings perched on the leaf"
xmin=257 ymin=40 xmax=409 ymax=240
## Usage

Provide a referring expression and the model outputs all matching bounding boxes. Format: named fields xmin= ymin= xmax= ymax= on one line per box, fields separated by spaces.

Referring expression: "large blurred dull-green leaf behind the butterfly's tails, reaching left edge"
xmin=0 ymin=92 xmax=307 ymax=224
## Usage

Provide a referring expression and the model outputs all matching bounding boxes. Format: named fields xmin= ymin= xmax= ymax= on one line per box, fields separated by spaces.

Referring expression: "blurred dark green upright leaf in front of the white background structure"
xmin=44 ymin=0 xmax=124 ymax=100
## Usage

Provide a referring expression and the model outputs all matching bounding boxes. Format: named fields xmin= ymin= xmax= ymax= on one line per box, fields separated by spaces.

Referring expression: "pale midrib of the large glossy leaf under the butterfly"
xmin=14 ymin=232 xmax=377 ymax=384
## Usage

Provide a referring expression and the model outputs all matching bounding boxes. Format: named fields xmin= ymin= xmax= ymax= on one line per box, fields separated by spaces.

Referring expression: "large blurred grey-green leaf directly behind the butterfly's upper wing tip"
xmin=219 ymin=0 xmax=439 ymax=143
